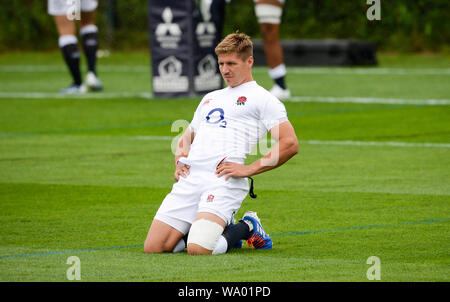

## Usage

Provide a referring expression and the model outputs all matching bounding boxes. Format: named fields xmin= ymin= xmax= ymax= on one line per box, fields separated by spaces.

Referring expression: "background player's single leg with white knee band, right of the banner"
xmin=254 ymin=0 xmax=291 ymax=100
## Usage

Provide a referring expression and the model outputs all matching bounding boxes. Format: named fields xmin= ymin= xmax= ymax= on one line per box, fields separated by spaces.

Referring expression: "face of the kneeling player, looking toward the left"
xmin=218 ymin=53 xmax=253 ymax=87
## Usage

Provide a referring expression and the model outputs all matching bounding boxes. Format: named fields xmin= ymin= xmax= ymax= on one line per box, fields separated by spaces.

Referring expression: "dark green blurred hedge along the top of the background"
xmin=0 ymin=0 xmax=450 ymax=52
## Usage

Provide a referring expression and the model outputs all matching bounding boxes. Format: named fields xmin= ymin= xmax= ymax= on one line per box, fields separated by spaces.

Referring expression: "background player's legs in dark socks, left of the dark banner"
xmin=48 ymin=0 xmax=103 ymax=94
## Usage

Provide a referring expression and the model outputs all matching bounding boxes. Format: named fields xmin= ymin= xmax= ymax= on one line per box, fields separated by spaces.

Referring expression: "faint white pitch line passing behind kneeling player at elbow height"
xmin=130 ymin=135 xmax=450 ymax=148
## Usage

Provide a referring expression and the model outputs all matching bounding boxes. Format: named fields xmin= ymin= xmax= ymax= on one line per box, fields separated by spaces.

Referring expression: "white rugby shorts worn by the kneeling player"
xmin=154 ymin=159 xmax=249 ymax=234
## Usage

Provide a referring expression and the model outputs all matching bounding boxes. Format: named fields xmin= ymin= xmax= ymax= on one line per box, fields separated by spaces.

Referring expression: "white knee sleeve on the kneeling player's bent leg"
xmin=188 ymin=219 xmax=223 ymax=251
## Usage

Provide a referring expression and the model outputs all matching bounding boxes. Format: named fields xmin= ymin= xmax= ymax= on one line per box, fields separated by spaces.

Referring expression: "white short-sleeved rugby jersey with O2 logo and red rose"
xmin=187 ymin=81 xmax=288 ymax=164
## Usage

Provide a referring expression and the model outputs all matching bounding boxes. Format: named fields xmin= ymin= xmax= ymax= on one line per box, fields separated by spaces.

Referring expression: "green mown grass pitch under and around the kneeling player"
xmin=0 ymin=53 xmax=450 ymax=281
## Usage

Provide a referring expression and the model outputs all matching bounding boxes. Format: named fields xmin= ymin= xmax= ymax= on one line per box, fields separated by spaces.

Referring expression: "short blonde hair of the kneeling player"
xmin=215 ymin=33 xmax=253 ymax=61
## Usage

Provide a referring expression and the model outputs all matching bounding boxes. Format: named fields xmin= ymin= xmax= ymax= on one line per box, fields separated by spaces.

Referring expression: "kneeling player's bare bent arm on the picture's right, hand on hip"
xmin=216 ymin=121 xmax=298 ymax=180
